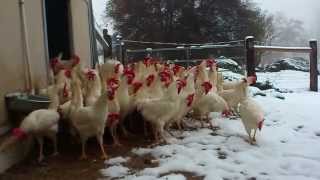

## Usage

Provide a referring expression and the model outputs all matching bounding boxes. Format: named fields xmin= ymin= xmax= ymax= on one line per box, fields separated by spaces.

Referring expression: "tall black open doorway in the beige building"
xmin=45 ymin=0 xmax=71 ymax=59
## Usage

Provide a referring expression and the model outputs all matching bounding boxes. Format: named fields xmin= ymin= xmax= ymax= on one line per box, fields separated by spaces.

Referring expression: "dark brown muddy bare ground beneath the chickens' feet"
xmin=0 ymin=117 xmax=203 ymax=180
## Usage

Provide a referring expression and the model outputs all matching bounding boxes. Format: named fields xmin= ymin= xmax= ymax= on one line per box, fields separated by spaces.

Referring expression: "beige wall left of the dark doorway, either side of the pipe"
xmin=0 ymin=0 xmax=47 ymax=126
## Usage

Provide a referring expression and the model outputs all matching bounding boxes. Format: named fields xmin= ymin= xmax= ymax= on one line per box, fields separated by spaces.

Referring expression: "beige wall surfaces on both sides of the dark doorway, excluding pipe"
xmin=0 ymin=0 xmax=91 ymax=128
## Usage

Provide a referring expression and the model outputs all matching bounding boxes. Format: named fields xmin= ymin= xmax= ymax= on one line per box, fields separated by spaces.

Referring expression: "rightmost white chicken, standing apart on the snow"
xmin=239 ymin=98 xmax=264 ymax=144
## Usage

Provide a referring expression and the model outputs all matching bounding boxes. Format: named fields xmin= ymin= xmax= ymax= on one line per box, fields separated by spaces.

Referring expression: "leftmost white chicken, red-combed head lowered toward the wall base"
xmin=0 ymin=87 xmax=60 ymax=162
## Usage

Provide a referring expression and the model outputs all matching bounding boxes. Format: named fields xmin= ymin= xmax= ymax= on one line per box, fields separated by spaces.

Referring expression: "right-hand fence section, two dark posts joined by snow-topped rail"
xmin=245 ymin=36 xmax=318 ymax=92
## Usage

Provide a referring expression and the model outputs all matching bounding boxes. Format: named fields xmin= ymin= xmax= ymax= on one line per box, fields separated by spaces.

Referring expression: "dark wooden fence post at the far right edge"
xmin=309 ymin=40 xmax=318 ymax=92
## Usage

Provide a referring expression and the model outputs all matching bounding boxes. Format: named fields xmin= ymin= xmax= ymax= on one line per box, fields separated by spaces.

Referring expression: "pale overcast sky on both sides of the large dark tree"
xmin=92 ymin=0 xmax=320 ymax=33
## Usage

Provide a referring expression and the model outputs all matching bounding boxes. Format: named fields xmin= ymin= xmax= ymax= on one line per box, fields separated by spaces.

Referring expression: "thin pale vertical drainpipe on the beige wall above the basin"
xmin=19 ymin=0 xmax=34 ymax=94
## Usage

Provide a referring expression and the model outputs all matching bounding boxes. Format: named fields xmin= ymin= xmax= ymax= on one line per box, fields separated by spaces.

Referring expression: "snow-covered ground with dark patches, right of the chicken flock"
xmin=101 ymin=71 xmax=320 ymax=180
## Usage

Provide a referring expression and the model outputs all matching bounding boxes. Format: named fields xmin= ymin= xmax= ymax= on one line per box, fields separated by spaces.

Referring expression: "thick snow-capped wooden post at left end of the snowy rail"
xmin=245 ymin=36 xmax=256 ymax=76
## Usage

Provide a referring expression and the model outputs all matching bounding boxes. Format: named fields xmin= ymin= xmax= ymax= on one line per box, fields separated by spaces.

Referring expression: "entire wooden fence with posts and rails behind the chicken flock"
xmin=112 ymin=36 xmax=318 ymax=91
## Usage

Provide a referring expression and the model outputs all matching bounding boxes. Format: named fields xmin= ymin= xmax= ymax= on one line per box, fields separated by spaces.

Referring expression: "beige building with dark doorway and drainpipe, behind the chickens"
xmin=0 ymin=0 xmax=106 ymax=171
